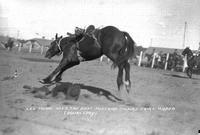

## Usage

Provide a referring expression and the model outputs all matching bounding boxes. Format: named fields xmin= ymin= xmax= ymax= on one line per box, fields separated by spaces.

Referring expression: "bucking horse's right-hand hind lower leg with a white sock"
xmin=124 ymin=61 xmax=131 ymax=93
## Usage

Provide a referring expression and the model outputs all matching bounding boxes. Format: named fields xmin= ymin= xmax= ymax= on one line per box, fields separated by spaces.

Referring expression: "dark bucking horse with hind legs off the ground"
xmin=42 ymin=26 xmax=135 ymax=92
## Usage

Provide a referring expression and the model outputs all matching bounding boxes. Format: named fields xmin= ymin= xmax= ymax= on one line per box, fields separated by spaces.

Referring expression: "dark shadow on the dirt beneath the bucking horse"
xmin=23 ymin=82 xmax=122 ymax=102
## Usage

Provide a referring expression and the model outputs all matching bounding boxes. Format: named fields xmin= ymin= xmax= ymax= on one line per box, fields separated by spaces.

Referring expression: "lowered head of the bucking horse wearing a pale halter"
xmin=45 ymin=34 xmax=62 ymax=59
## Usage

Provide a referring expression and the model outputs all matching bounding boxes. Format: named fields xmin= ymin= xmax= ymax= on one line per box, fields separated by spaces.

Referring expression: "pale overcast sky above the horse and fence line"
xmin=0 ymin=0 xmax=200 ymax=49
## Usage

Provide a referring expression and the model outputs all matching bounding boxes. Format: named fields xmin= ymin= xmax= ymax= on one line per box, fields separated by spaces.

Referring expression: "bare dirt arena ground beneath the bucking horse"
xmin=0 ymin=50 xmax=200 ymax=135
